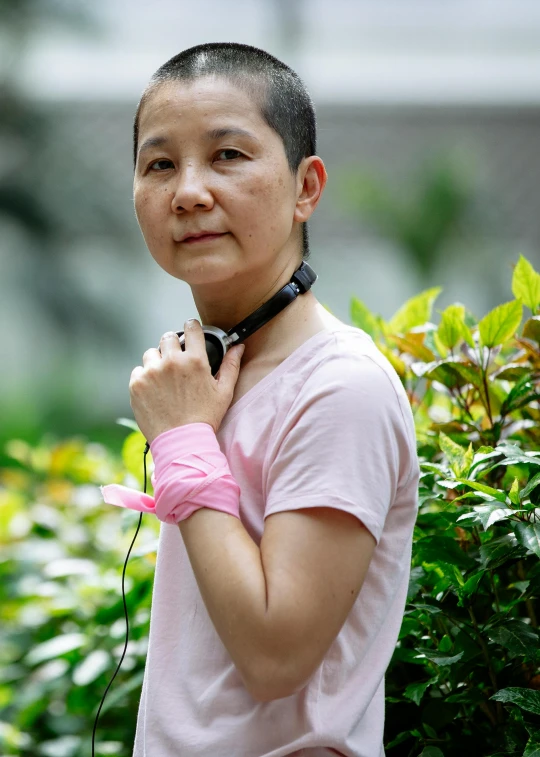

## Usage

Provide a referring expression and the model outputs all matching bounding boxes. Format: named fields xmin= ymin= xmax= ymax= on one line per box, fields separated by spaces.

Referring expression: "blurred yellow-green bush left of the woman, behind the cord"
xmin=0 ymin=433 xmax=158 ymax=757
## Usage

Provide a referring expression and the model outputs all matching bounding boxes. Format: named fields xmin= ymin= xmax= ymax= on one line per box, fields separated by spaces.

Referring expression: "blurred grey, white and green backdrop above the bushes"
xmin=0 ymin=0 xmax=540 ymax=444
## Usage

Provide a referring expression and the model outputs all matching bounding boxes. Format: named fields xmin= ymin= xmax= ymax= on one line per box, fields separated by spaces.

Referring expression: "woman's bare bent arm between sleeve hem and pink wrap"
xmin=179 ymin=500 xmax=375 ymax=701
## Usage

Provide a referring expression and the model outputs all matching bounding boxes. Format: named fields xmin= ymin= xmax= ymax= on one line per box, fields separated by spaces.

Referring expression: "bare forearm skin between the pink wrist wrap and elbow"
xmin=178 ymin=508 xmax=288 ymax=698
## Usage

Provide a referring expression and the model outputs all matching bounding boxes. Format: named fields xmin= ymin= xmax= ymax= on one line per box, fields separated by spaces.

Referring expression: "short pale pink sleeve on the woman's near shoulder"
xmin=264 ymin=355 xmax=410 ymax=543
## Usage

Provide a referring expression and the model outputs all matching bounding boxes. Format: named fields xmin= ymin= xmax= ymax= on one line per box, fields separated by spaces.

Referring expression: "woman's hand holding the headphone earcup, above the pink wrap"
xmin=129 ymin=320 xmax=244 ymax=444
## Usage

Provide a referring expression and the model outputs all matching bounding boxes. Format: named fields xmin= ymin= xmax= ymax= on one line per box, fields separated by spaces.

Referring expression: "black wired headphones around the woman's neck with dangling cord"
xmin=92 ymin=261 xmax=317 ymax=757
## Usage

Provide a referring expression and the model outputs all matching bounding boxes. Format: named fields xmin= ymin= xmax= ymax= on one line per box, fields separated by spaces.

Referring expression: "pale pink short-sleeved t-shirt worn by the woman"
xmin=133 ymin=325 xmax=419 ymax=757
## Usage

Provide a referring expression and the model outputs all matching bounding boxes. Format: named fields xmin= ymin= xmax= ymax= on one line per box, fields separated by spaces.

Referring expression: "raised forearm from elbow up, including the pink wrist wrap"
xmin=103 ymin=423 xmax=299 ymax=698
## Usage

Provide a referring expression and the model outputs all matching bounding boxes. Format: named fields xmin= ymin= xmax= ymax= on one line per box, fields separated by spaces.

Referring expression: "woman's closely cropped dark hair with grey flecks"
xmin=133 ymin=42 xmax=317 ymax=260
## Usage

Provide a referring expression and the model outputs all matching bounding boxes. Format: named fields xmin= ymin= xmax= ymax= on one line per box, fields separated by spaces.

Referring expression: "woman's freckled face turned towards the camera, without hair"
xmin=134 ymin=77 xmax=304 ymax=286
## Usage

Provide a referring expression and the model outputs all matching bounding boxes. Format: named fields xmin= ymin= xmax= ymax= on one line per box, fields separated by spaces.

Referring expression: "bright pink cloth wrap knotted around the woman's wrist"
xmin=101 ymin=423 xmax=240 ymax=524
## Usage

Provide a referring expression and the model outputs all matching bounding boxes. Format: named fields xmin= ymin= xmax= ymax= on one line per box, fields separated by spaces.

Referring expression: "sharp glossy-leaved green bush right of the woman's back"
xmin=352 ymin=257 xmax=540 ymax=757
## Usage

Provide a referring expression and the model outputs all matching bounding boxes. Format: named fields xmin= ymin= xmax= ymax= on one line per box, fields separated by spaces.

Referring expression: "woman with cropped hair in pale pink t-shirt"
xmin=104 ymin=43 xmax=418 ymax=757
